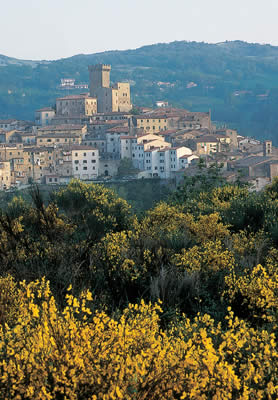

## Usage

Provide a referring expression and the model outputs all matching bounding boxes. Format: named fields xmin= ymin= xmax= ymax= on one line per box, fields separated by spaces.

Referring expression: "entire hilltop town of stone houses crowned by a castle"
xmin=0 ymin=64 xmax=278 ymax=190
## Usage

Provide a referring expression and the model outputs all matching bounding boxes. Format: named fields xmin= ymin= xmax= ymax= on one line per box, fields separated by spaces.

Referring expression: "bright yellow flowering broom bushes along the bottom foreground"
xmin=0 ymin=280 xmax=278 ymax=400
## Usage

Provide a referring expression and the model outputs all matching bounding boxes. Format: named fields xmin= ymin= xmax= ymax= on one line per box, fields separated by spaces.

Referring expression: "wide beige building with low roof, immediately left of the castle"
xmin=56 ymin=94 xmax=97 ymax=117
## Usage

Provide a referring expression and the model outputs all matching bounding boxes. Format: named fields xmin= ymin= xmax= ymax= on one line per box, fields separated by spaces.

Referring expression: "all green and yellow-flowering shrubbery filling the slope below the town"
xmin=0 ymin=177 xmax=278 ymax=400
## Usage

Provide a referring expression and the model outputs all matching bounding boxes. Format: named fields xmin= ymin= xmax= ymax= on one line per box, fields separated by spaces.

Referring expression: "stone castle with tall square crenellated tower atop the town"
xmin=88 ymin=64 xmax=132 ymax=113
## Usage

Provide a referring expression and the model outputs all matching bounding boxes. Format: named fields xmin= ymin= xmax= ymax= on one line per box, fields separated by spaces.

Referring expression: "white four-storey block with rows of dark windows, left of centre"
xmin=71 ymin=145 xmax=99 ymax=180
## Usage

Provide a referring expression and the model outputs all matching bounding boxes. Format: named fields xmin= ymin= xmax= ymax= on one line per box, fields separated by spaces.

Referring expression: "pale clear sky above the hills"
xmin=0 ymin=0 xmax=278 ymax=60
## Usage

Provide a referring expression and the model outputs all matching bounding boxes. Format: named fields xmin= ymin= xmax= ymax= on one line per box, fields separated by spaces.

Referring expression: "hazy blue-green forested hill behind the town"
xmin=0 ymin=41 xmax=278 ymax=144
